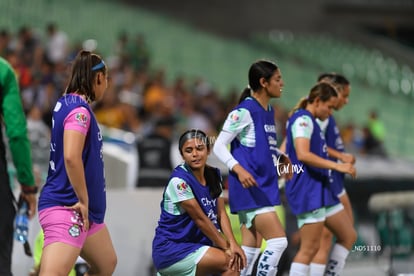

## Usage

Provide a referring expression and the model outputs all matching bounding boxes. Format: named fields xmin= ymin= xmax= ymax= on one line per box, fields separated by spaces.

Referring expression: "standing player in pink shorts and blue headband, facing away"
xmin=38 ymin=51 xmax=117 ymax=275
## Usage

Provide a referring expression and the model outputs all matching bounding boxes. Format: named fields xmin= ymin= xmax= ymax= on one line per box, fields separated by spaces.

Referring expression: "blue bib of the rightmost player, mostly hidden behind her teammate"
xmin=318 ymin=115 xmax=345 ymax=194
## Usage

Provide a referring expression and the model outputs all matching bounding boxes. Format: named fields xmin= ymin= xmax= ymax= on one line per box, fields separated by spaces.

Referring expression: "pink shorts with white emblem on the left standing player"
xmin=39 ymin=206 xmax=105 ymax=248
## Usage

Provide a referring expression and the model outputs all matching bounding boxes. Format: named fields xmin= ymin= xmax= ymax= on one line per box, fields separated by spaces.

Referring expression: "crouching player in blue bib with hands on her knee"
xmin=152 ymin=129 xmax=246 ymax=275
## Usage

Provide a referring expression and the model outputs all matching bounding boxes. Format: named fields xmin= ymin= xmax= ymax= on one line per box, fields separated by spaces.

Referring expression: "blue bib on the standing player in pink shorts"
xmin=38 ymin=94 xmax=106 ymax=223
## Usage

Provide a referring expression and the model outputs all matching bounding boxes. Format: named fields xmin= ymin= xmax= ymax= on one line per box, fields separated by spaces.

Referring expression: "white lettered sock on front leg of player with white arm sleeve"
xmin=257 ymin=237 xmax=287 ymax=276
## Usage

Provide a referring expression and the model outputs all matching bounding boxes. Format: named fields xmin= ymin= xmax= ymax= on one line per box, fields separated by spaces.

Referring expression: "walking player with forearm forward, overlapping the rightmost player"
xmin=285 ymin=82 xmax=356 ymax=276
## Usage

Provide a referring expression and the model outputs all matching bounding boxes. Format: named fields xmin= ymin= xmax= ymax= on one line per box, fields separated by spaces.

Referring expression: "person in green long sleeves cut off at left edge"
xmin=0 ymin=57 xmax=37 ymax=276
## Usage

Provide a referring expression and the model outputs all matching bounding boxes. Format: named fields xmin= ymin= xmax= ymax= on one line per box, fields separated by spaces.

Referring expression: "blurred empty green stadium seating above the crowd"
xmin=0 ymin=0 xmax=414 ymax=158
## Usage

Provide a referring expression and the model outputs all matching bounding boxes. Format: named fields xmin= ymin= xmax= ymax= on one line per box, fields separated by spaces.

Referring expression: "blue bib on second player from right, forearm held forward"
xmin=285 ymin=109 xmax=339 ymax=215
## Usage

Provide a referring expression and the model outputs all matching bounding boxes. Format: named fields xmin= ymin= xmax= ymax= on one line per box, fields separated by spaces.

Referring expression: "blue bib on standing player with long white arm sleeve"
xmin=228 ymin=97 xmax=280 ymax=213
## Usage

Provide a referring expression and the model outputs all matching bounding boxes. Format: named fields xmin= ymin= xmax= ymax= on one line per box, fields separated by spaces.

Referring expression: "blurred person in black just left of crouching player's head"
xmin=136 ymin=117 xmax=174 ymax=187
